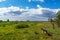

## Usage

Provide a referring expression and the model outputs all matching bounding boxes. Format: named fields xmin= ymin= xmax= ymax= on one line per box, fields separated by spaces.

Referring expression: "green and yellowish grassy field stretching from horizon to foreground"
xmin=0 ymin=21 xmax=60 ymax=40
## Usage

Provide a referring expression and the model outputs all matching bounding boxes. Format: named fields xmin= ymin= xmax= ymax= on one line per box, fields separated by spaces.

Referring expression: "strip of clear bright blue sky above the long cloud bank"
xmin=0 ymin=0 xmax=60 ymax=9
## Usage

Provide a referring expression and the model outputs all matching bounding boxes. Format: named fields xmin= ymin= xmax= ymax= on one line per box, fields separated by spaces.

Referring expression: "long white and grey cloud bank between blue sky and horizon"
xmin=0 ymin=5 xmax=60 ymax=20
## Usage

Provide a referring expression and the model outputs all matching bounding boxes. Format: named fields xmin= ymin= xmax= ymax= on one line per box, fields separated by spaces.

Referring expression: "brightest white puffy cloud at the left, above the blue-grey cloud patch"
xmin=0 ymin=6 xmax=24 ymax=15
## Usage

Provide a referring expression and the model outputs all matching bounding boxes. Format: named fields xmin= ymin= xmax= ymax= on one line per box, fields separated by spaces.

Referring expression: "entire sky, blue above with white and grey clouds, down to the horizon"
xmin=0 ymin=0 xmax=60 ymax=21
